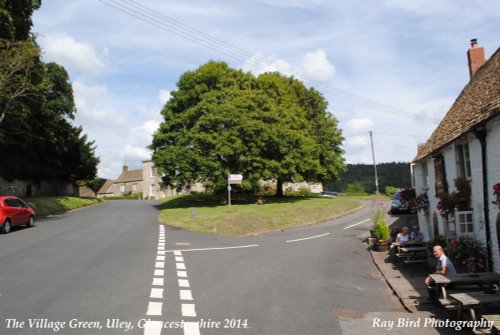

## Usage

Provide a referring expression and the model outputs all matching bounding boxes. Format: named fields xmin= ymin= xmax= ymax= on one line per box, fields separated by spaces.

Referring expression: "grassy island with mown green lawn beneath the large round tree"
xmin=160 ymin=195 xmax=360 ymax=236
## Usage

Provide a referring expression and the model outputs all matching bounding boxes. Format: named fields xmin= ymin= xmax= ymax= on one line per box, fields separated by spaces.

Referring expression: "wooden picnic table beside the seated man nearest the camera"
xmin=429 ymin=272 xmax=500 ymax=301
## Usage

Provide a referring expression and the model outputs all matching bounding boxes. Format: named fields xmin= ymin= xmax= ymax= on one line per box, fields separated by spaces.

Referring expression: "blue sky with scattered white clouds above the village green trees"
xmin=32 ymin=0 xmax=500 ymax=179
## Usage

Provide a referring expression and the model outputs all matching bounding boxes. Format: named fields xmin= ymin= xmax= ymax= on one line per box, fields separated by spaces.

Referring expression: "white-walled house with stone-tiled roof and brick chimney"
xmin=412 ymin=40 xmax=500 ymax=272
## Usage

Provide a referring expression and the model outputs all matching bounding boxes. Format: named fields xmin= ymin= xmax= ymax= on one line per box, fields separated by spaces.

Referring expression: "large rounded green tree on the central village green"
xmin=150 ymin=61 xmax=344 ymax=194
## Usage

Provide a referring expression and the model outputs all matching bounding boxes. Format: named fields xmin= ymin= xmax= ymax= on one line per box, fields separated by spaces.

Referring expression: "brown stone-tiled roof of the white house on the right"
xmin=414 ymin=48 xmax=500 ymax=162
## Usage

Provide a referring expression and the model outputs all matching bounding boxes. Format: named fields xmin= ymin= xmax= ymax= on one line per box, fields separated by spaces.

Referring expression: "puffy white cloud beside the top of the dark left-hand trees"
xmin=40 ymin=33 xmax=109 ymax=77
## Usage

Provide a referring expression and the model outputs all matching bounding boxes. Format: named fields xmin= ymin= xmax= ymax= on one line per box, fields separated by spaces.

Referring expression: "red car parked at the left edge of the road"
xmin=0 ymin=196 xmax=35 ymax=234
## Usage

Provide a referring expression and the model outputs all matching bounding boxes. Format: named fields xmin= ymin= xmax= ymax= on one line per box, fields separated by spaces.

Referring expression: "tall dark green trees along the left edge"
xmin=0 ymin=0 xmax=99 ymax=182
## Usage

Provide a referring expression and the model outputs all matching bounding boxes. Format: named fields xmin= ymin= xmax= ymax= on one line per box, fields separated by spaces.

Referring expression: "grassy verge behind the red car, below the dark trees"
xmin=26 ymin=197 xmax=101 ymax=217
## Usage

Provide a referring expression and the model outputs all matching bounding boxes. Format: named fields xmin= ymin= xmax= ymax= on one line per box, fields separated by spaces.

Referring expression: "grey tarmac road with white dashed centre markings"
xmin=0 ymin=201 xmax=403 ymax=335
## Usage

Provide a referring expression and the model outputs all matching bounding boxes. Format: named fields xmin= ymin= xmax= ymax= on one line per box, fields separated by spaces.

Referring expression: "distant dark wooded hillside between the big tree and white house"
xmin=326 ymin=163 xmax=411 ymax=193
